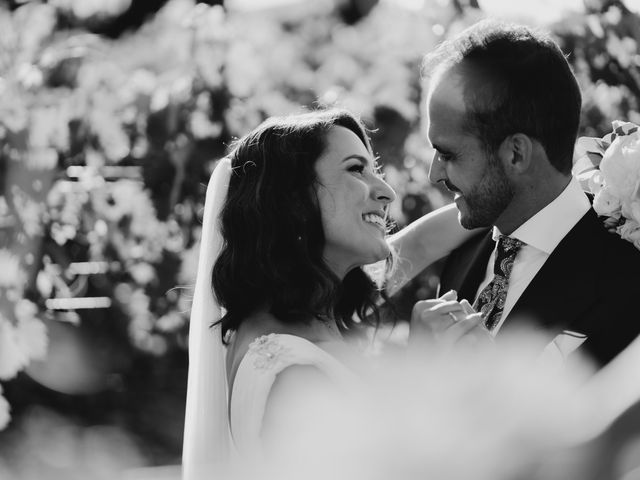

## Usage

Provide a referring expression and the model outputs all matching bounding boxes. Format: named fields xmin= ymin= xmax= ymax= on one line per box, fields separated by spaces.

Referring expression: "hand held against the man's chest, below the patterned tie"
xmin=409 ymin=291 xmax=493 ymax=350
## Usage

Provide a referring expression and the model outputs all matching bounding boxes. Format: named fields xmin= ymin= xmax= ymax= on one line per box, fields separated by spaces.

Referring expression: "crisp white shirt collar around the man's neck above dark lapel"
xmin=492 ymin=177 xmax=591 ymax=255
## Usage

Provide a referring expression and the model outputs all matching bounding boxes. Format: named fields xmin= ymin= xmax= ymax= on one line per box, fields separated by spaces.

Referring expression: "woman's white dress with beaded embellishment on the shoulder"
xmin=229 ymin=333 xmax=356 ymax=458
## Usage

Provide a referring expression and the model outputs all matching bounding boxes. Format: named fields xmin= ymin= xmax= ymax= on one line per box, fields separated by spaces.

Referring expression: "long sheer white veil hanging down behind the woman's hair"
xmin=182 ymin=158 xmax=232 ymax=480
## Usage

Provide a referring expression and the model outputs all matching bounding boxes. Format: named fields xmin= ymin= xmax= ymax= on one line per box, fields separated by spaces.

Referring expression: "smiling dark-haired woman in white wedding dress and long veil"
xmin=183 ymin=109 xmax=478 ymax=480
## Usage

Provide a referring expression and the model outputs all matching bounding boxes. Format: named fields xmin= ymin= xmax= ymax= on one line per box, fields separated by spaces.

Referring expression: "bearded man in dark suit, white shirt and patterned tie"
xmin=414 ymin=21 xmax=640 ymax=365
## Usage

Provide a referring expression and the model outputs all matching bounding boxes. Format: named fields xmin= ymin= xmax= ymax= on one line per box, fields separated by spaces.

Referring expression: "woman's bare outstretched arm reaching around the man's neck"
xmin=386 ymin=203 xmax=477 ymax=296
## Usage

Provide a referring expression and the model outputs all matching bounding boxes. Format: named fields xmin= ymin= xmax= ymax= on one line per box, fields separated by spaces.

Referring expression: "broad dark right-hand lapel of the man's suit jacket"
xmin=500 ymin=210 xmax=607 ymax=333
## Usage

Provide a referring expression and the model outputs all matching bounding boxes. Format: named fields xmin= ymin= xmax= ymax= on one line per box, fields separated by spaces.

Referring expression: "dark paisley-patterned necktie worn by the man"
xmin=473 ymin=235 xmax=525 ymax=330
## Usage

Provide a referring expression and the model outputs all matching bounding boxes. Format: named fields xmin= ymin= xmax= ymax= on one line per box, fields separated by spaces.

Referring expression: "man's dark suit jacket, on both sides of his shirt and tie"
xmin=440 ymin=209 xmax=640 ymax=365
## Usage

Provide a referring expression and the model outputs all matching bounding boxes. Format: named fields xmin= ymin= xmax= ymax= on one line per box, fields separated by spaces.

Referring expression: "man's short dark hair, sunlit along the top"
xmin=423 ymin=20 xmax=581 ymax=173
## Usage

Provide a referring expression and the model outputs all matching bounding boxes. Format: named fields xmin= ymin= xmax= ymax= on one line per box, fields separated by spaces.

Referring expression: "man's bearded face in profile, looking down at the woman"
xmin=428 ymin=77 xmax=514 ymax=229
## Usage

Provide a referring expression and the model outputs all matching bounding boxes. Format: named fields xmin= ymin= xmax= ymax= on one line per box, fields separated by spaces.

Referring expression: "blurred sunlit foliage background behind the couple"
xmin=0 ymin=0 xmax=640 ymax=480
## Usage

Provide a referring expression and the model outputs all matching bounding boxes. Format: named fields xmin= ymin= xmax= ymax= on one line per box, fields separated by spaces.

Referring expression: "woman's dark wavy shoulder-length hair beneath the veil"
xmin=212 ymin=109 xmax=391 ymax=335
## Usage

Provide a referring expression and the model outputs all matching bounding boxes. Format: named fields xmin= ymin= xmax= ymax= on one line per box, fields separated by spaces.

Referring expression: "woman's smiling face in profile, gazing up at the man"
xmin=315 ymin=126 xmax=396 ymax=278
